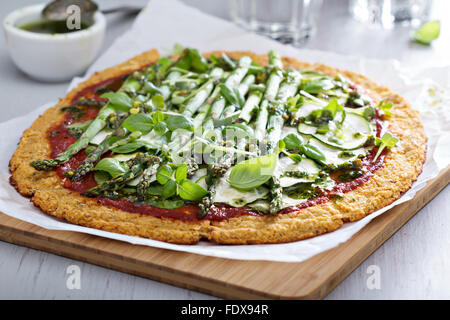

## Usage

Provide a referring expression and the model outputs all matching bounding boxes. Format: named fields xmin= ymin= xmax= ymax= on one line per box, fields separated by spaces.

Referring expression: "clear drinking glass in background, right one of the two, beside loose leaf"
xmin=349 ymin=0 xmax=432 ymax=28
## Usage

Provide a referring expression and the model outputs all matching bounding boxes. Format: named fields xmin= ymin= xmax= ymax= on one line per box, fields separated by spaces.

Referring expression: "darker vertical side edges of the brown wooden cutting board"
xmin=0 ymin=167 xmax=450 ymax=299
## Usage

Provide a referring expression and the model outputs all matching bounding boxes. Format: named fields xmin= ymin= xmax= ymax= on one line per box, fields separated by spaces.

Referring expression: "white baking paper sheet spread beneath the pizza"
xmin=0 ymin=0 xmax=450 ymax=262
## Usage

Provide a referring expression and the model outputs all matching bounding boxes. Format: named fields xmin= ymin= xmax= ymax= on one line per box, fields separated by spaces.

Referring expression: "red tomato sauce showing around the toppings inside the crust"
xmin=48 ymin=77 xmax=385 ymax=222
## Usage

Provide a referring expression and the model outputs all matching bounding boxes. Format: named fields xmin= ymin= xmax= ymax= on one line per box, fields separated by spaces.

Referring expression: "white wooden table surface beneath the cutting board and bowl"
xmin=0 ymin=0 xmax=450 ymax=299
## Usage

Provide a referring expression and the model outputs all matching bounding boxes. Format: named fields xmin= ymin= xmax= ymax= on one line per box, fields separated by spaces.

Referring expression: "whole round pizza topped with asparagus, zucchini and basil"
xmin=10 ymin=48 xmax=427 ymax=244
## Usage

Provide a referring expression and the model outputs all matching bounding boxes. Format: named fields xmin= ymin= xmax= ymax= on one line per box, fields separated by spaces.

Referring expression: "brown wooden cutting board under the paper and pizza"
xmin=0 ymin=167 xmax=450 ymax=299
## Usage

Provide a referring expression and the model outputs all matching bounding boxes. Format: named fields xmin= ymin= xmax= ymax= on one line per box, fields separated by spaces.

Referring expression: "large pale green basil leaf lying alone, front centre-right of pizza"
xmin=228 ymin=153 xmax=278 ymax=190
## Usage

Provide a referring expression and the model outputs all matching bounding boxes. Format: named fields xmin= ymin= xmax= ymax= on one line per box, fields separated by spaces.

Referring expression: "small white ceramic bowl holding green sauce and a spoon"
xmin=3 ymin=4 xmax=106 ymax=81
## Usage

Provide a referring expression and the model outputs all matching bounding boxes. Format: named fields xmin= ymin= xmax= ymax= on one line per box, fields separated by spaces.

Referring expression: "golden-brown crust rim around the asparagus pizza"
xmin=10 ymin=50 xmax=427 ymax=244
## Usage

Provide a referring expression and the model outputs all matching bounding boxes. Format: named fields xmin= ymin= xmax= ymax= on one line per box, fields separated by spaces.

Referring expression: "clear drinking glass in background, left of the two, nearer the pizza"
xmin=231 ymin=0 xmax=322 ymax=46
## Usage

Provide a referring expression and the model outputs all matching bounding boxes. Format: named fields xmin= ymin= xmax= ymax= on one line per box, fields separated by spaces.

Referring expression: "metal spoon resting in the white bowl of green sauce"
xmin=42 ymin=0 xmax=142 ymax=21
